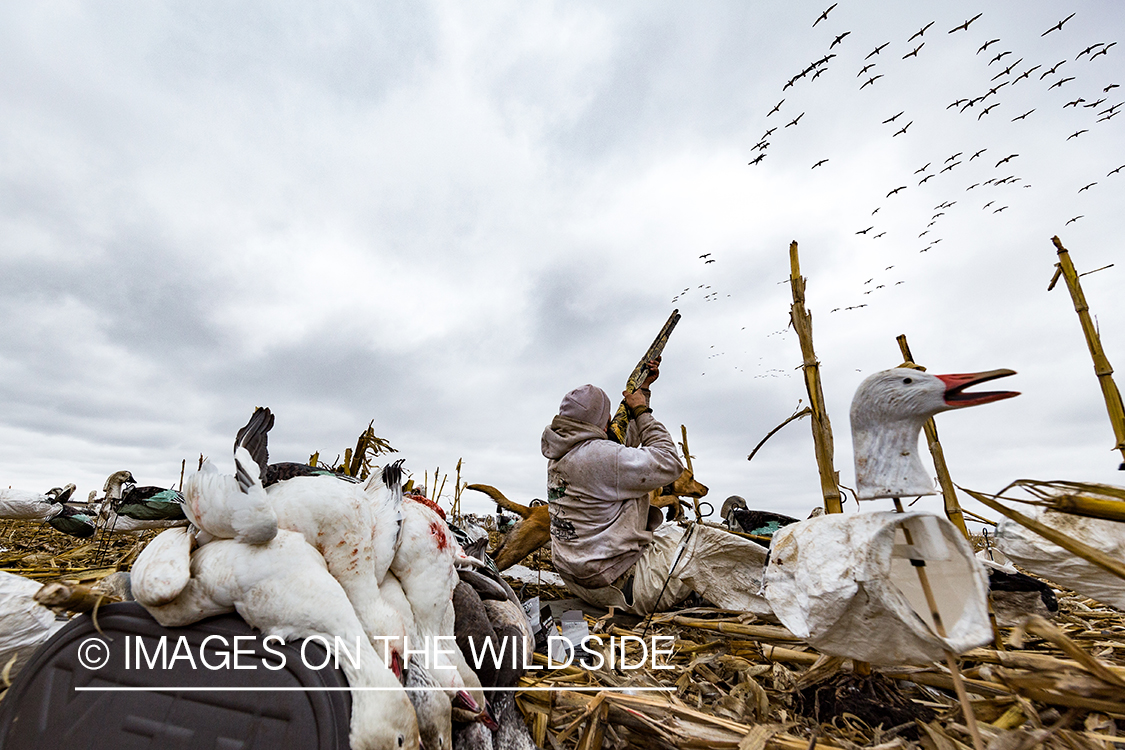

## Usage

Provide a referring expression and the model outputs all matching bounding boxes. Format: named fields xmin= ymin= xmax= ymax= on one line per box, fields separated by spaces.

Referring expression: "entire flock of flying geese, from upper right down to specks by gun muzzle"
xmin=672 ymin=2 xmax=1125 ymax=377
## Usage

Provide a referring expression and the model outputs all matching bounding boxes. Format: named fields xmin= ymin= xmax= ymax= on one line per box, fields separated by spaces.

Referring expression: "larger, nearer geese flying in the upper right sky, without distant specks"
xmin=749 ymin=3 xmax=1125 ymax=313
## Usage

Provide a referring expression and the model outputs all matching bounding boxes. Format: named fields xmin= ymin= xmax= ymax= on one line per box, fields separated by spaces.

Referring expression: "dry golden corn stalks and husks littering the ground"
xmin=0 ymin=510 xmax=1125 ymax=750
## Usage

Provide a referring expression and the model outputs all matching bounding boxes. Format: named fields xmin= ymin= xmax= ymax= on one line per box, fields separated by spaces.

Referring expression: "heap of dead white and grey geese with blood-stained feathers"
xmin=2 ymin=408 xmax=534 ymax=750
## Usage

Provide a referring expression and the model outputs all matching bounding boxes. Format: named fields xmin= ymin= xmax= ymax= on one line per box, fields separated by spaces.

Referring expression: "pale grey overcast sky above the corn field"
xmin=0 ymin=0 xmax=1125 ymax=528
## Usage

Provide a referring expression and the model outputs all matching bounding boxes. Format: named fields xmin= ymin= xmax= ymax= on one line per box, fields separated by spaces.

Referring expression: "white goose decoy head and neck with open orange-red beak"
xmin=852 ymin=368 xmax=1019 ymax=500
